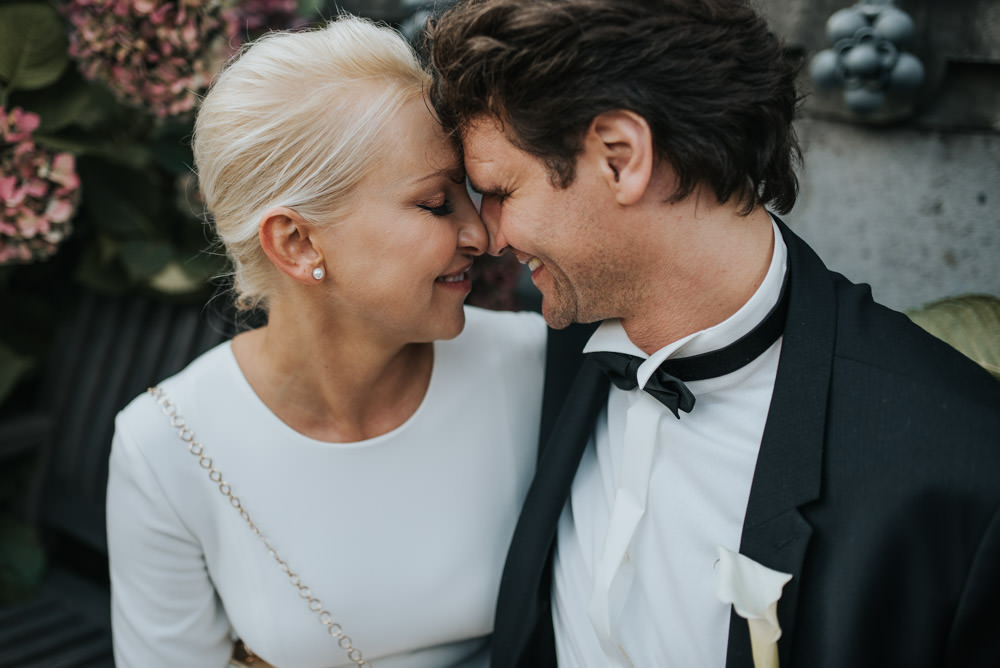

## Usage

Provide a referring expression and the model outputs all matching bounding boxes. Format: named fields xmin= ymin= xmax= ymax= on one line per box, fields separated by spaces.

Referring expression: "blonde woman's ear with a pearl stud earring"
xmin=257 ymin=207 xmax=324 ymax=284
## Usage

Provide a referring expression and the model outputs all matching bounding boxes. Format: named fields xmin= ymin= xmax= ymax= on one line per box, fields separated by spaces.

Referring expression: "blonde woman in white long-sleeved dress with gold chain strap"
xmin=107 ymin=17 xmax=546 ymax=668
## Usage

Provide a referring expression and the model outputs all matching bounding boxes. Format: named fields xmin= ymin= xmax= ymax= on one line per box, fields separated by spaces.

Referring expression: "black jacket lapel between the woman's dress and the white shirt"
xmin=492 ymin=348 xmax=609 ymax=666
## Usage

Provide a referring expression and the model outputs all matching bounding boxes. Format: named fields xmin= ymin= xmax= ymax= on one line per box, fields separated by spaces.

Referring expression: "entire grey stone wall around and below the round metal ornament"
xmin=758 ymin=0 xmax=1000 ymax=309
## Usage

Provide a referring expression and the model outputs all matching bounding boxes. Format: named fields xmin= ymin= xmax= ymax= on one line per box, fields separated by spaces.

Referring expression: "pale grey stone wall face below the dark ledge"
xmin=785 ymin=118 xmax=1000 ymax=309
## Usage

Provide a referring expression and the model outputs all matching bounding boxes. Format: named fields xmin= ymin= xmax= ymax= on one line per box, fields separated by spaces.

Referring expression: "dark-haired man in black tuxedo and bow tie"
xmin=429 ymin=0 xmax=1000 ymax=668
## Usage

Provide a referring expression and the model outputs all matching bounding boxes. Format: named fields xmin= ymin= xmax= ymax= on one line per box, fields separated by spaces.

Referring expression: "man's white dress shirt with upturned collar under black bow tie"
xmin=552 ymin=223 xmax=787 ymax=668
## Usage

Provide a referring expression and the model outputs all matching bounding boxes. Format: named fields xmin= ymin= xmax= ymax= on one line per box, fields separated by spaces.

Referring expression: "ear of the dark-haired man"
xmin=585 ymin=109 xmax=654 ymax=206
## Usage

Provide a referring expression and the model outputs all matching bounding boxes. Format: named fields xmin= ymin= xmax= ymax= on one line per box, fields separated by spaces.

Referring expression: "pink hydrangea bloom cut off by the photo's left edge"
xmin=0 ymin=107 xmax=80 ymax=265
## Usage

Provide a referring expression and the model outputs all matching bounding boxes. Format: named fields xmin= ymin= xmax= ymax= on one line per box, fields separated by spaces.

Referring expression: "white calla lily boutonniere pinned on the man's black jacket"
xmin=716 ymin=545 xmax=792 ymax=668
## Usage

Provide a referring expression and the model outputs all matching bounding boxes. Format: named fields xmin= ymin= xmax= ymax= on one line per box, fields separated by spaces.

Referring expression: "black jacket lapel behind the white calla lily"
xmin=726 ymin=221 xmax=836 ymax=668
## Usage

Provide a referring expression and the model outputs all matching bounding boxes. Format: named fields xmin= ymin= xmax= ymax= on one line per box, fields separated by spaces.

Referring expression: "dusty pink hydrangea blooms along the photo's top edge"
xmin=62 ymin=0 xmax=296 ymax=117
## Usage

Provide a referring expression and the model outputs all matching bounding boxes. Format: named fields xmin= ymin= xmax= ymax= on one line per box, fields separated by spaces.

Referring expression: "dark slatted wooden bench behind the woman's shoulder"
xmin=0 ymin=293 xmax=242 ymax=668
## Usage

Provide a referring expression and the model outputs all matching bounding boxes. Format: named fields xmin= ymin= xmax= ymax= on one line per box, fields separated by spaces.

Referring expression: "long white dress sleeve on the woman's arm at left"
xmin=107 ymin=423 xmax=232 ymax=668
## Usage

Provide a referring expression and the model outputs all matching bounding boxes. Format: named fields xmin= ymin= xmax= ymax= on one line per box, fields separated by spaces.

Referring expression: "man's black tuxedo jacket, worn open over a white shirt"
xmin=492 ymin=224 xmax=1000 ymax=668
